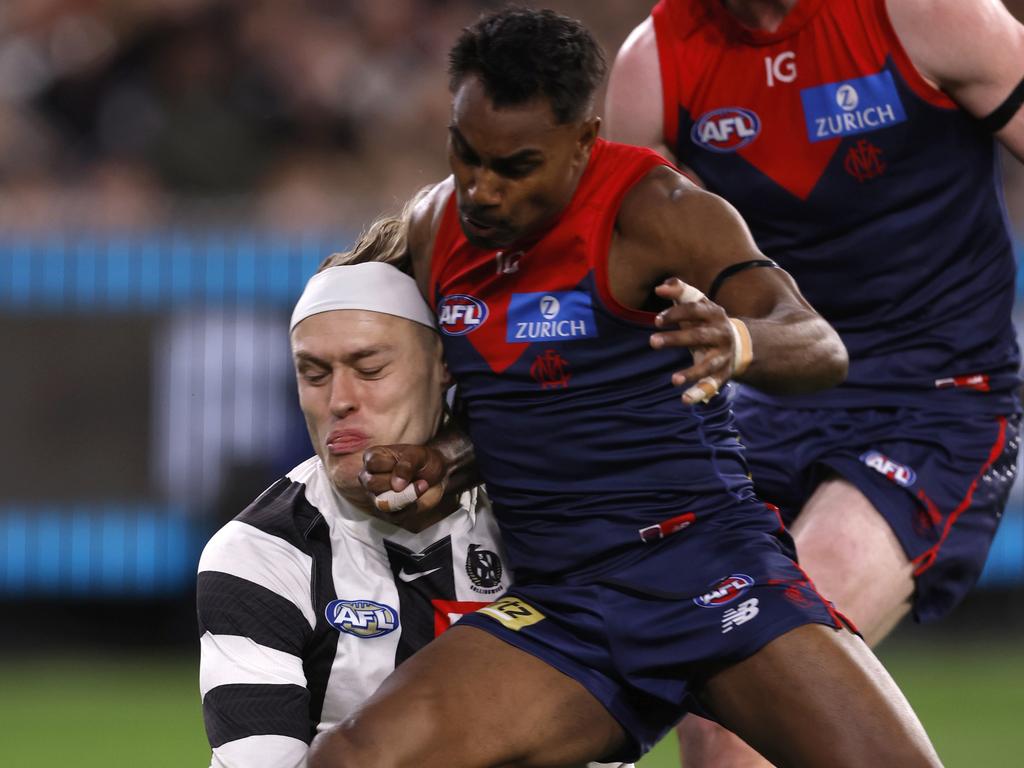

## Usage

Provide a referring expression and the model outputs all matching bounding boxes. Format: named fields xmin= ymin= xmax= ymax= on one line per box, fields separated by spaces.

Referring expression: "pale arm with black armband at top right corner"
xmin=886 ymin=0 xmax=1024 ymax=161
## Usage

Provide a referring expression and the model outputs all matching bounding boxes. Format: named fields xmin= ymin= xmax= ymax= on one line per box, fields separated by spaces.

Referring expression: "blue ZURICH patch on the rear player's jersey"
xmin=800 ymin=72 xmax=906 ymax=141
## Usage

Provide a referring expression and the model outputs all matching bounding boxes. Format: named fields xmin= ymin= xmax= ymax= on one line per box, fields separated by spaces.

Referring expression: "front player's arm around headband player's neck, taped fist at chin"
xmin=359 ymin=178 xmax=479 ymax=520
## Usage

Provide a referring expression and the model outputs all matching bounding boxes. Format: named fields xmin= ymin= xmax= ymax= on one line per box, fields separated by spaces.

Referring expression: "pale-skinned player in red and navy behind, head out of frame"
xmin=606 ymin=0 xmax=1024 ymax=766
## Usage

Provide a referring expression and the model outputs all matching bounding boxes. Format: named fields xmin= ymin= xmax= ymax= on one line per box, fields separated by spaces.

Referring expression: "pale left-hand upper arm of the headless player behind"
xmin=604 ymin=16 xmax=671 ymax=157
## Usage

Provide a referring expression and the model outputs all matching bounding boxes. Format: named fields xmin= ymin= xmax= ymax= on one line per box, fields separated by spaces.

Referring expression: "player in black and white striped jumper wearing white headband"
xmin=198 ymin=217 xmax=510 ymax=768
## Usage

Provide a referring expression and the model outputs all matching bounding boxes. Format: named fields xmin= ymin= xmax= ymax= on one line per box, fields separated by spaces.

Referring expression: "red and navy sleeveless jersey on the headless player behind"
xmin=651 ymin=0 xmax=1020 ymax=413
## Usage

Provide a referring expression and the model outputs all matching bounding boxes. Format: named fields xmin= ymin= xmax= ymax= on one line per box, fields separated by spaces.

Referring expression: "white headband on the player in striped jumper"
xmin=288 ymin=261 xmax=436 ymax=333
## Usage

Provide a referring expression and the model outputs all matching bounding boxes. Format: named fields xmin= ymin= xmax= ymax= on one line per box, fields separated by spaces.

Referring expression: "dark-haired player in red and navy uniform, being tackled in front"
xmin=310 ymin=9 xmax=938 ymax=768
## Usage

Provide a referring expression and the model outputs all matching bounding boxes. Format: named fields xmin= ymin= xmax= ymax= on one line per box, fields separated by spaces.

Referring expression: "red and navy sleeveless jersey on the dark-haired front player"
xmin=430 ymin=140 xmax=753 ymax=583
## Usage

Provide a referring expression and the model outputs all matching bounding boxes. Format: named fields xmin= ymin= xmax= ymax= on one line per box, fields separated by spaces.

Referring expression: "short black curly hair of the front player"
xmin=449 ymin=6 xmax=607 ymax=125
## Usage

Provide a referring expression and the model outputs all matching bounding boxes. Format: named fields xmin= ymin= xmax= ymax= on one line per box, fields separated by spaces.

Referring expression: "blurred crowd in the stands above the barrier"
xmin=0 ymin=0 xmax=1024 ymax=236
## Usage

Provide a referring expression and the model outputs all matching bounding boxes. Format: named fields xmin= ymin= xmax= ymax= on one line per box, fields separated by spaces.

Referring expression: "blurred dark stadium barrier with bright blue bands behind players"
xmin=0 ymin=237 xmax=1024 ymax=599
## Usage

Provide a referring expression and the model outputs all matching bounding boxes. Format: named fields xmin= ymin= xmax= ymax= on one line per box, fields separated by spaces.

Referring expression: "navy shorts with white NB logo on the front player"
xmin=460 ymin=500 xmax=848 ymax=762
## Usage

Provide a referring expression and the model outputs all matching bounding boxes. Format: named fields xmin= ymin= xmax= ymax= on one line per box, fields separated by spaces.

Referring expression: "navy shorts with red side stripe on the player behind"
xmin=733 ymin=396 xmax=1020 ymax=622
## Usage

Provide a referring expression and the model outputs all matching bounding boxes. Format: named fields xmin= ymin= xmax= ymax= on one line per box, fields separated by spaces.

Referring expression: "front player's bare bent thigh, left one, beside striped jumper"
xmin=346 ymin=626 xmax=624 ymax=768
